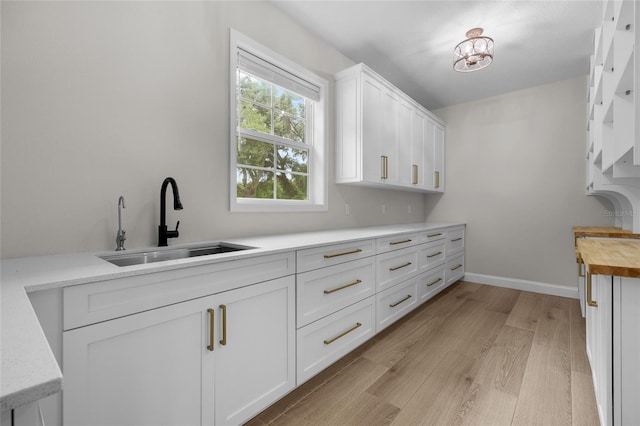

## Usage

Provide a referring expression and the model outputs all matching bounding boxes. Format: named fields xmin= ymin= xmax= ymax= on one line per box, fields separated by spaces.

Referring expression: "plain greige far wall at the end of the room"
xmin=425 ymin=76 xmax=613 ymax=287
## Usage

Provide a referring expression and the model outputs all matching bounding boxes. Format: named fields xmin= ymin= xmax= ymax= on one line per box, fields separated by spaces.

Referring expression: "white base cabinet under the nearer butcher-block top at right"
xmin=586 ymin=274 xmax=640 ymax=425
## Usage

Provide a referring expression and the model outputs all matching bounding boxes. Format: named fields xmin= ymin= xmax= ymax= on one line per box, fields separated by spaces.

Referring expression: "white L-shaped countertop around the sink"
xmin=0 ymin=222 xmax=463 ymax=411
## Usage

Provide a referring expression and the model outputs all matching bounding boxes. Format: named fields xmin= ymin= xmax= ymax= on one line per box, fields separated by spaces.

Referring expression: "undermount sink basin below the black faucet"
xmin=98 ymin=243 xmax=255 ymax=266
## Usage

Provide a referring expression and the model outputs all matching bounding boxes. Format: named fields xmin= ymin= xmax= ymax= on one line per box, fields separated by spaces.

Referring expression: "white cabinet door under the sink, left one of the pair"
xmin=63 ymin=297 xmax=214 ymax=425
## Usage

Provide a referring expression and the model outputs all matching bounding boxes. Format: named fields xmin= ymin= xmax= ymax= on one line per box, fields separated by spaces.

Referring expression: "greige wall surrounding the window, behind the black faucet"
xmin=0 ymin=1 xmax=424 ymax=257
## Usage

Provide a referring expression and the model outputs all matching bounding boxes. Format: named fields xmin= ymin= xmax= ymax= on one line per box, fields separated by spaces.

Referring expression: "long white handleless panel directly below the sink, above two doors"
xmin=63 ymin=252 xmax=295 ymax=330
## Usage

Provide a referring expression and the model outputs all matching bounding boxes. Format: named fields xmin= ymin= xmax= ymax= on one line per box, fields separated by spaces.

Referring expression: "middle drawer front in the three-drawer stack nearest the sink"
xmin=296 ymin=257 xmax=376 ymax=328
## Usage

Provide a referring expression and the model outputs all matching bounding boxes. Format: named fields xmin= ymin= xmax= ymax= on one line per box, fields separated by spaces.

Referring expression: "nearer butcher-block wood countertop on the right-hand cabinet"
xmin=578 ymin=239 xmax=640 ymax=278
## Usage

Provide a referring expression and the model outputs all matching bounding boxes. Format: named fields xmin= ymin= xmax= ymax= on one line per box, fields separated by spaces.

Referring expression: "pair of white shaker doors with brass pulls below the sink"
xmin=63 ymin=276 xmax=295 ymax=425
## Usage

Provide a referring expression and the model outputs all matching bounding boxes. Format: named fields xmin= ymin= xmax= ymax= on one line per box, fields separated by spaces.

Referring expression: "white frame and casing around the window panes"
xmin=229 ymin=29 xmax=329 ymax=212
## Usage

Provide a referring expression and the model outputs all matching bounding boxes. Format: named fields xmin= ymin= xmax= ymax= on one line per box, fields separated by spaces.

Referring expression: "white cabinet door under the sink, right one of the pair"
xmin=214 ymin=276 xmax=296 ymax=425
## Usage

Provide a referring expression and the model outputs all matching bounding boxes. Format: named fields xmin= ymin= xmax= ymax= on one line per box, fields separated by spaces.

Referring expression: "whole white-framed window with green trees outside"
xmin=230 ymin=30 xmax=328 ymax=211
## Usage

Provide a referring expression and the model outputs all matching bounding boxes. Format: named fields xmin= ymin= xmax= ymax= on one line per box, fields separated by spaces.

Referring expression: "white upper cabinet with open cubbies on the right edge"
xmin=586 ymin=0 xmax=640 ymax=232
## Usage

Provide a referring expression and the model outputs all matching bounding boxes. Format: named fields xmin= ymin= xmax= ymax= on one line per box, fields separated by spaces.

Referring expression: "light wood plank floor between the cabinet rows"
xmin=249 ymin=281 xmax=598 ymax=426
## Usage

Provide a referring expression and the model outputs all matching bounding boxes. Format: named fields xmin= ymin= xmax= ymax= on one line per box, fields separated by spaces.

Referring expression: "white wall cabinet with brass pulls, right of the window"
xmin=336 ymin=64 xmax=445 ymax=192
